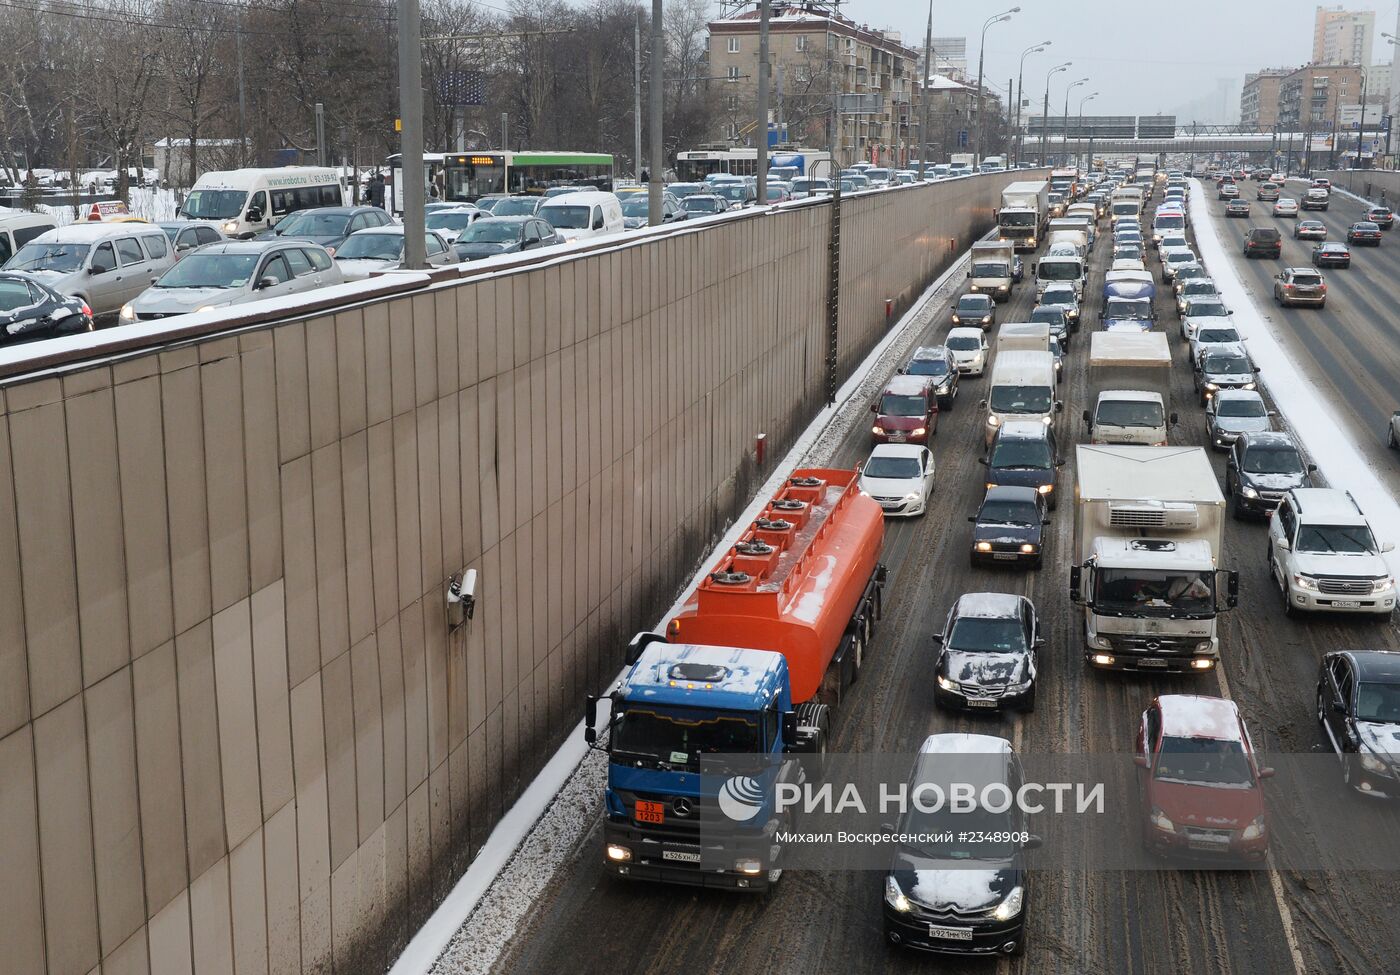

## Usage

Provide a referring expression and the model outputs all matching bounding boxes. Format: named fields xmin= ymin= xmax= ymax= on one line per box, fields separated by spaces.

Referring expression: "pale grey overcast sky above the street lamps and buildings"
xmin=841 ymin=0 xmax=1396 ymax=120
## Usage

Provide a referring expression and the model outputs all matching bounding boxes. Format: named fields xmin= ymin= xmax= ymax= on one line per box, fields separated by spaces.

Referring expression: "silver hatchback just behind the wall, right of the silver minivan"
xmin=122 ymin=241 xmax=343 ymax=324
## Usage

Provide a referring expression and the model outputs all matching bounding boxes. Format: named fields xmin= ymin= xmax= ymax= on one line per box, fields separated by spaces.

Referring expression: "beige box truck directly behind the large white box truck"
xmin=1086 ymin=326 xmax=1177 ymax=447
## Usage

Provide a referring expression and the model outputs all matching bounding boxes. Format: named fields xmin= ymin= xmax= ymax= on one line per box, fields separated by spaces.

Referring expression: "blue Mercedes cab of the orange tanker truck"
xmin=584 ymin=633 xmax=827 ymax=891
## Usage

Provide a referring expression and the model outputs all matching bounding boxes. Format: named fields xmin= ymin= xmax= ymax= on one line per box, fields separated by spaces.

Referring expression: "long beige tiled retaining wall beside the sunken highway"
xmin=0 ymin=175 xmax=1041 ymax=975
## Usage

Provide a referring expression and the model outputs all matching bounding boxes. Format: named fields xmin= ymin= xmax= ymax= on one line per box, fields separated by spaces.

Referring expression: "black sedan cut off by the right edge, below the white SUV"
xmin=1317 ymin=650 xmax=1400 ymax=798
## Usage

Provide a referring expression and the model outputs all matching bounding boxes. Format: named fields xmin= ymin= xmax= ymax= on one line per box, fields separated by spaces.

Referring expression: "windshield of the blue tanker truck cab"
xmin=612 ymin=707 xmax=759 ymax=765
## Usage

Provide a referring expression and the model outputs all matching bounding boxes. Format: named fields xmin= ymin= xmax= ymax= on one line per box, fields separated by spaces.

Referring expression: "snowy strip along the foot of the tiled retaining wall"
xmin=406 ymin=233 xmax=985 ymax=975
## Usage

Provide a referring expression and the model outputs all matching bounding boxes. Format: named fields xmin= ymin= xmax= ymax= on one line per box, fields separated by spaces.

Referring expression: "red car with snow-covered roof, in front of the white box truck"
xmin=1134 ymin=693 xmax=1274 ymax=860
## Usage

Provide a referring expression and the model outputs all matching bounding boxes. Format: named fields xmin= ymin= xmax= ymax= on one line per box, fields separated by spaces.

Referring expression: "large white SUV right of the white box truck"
xmin=1268 ymin=488 xmax=1396 ymax=615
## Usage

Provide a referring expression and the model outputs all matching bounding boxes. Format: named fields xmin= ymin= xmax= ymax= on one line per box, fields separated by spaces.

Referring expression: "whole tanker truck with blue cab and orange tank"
xmin=584 ymin=468 xmax=886 ymax=891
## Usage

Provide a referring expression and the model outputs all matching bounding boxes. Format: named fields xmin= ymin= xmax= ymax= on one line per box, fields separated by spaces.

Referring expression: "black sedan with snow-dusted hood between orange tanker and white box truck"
xmin=934 ymin=593 xmax=1044 ymax=712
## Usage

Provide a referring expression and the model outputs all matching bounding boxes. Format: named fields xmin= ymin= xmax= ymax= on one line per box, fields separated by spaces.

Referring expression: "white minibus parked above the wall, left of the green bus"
xmin=179 ymin=165 xmax=347 ymax=238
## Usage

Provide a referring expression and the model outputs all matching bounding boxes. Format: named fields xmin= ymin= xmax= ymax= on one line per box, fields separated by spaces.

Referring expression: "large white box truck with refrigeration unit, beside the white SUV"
xmin=1070 ymin=444 xmax=1239 ymax=674
